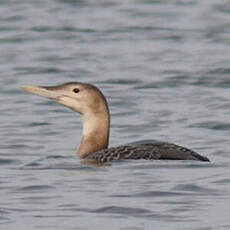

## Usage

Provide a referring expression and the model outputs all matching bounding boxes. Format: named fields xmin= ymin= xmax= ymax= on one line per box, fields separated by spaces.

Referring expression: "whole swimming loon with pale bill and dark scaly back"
xmin=21 ymin=82 xmax=210 ymax=164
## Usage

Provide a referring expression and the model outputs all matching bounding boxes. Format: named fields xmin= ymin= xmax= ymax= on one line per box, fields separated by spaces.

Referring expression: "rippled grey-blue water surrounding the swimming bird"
xmin=0 ymin=0 xmax=230 ymax=230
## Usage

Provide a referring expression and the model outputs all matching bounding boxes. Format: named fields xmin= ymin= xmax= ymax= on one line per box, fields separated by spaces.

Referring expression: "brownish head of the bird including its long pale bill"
xmin=21 ymin=82 xmax=108 ymax=116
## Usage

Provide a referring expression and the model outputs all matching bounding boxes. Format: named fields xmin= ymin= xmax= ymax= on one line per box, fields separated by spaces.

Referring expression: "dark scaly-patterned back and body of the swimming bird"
xmin=86 ymin=141 xmax=209 ymax=163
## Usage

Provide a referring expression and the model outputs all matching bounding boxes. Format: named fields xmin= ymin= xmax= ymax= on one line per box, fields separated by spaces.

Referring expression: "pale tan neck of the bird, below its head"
xmin=77 ymin=108 xmax=110 ymax=158
